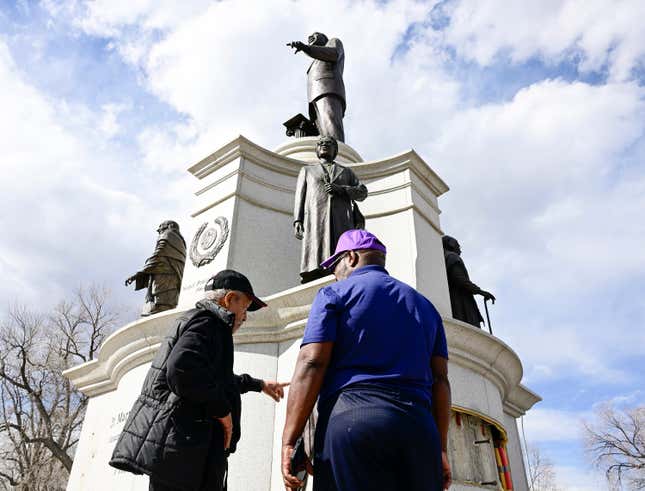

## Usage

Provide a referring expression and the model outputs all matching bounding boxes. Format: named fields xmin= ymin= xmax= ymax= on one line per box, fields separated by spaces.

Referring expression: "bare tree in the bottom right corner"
xmin=585 ymin=405 xmax=645 ymax=489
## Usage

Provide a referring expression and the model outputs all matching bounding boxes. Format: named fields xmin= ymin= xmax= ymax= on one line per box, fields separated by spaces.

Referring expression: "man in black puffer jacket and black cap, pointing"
xmin=110 ymin=270 xmax=287 ymax=491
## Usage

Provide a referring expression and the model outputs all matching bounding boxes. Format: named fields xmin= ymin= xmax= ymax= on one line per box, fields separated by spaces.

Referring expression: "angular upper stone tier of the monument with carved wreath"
xmin=178 ymin=136 xmax=450 ymax=315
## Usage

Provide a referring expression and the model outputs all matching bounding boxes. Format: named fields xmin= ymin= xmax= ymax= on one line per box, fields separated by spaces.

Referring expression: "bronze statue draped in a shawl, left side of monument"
xmin=125 ymin=220 xmax=186 ymax=317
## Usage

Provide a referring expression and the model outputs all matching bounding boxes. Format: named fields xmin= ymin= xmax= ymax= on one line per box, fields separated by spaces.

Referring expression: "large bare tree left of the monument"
xmin=0 ymin=287 xmax=117 ymax=491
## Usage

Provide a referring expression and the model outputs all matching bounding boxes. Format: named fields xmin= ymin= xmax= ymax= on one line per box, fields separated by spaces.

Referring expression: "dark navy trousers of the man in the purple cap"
xmin=314 ymin=384 xmax=443 ymax=491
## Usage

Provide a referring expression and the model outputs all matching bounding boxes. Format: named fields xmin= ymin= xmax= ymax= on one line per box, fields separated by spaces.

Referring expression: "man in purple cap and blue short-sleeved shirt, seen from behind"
xmin=282 ymin=230 xmax=451 ymax=491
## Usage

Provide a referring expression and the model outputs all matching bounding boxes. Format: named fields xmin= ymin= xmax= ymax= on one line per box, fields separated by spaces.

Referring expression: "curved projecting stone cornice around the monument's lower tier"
xmin=64 ymin=276 xmax=541 ymax=417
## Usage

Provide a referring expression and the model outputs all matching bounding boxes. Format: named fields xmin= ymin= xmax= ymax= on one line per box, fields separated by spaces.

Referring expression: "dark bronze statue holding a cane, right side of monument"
xmin=442 ymin=235 xmax=495 ymax=329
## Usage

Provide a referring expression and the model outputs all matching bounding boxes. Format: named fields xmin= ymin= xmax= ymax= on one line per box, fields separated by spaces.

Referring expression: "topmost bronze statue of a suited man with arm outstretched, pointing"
xmin=287 ymin=32 xmax=347 ymax=142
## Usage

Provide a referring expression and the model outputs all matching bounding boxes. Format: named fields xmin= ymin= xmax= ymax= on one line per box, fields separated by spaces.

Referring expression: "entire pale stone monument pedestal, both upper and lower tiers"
xmin=65 ymin=136 xmax=539 ymax=490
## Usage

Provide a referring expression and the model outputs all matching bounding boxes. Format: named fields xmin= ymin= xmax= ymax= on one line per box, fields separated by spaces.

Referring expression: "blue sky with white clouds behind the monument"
xmin=0 ymin=0 xmax=645 ymax=490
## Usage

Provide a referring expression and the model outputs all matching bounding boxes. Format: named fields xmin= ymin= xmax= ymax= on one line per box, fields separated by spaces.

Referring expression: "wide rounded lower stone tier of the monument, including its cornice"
xmin=65 ymin=277 xmax=539 ymax=491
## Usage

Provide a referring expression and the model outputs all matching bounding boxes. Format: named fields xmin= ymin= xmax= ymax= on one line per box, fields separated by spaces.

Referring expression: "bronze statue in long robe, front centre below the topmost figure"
xmin=293 ymin=136 xmax=367 ymax=283
